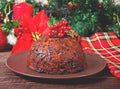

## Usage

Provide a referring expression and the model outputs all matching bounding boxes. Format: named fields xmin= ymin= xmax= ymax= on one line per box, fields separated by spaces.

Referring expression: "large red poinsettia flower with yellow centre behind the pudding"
xmin=11 ymin=10 xmax=49 ymax=54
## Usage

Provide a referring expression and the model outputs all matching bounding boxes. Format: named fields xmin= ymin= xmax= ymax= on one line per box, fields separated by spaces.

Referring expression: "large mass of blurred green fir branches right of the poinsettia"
xmin=45 ymin=0 xmax=120 ymax=37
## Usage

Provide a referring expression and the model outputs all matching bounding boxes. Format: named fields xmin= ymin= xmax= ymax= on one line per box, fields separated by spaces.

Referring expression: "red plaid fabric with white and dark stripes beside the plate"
xmin=81 ymin=32 xmax=120 ymax=78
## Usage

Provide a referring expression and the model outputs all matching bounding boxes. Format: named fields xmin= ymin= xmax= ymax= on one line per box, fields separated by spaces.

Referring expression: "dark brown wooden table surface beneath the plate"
xmin=0 ymin=51 xmax=120 ymax=89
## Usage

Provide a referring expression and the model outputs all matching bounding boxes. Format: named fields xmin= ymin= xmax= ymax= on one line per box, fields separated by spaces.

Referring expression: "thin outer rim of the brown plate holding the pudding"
xmin=5 ymin=50 xmax=106 ymax=79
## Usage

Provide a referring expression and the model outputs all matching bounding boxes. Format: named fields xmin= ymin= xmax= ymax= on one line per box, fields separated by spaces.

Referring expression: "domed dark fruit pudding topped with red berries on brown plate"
xmin=27 ymin=21 xmax=87 ymax=74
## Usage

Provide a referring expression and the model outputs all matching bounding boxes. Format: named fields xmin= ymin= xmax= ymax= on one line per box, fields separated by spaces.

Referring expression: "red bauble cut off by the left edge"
xmin=0 ymin=29 xmax=7 ymax=51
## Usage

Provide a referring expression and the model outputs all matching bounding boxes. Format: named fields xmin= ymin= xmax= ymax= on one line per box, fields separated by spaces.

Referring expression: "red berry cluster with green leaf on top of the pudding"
xmin=48 ymin=17 xmax=72 ymax=38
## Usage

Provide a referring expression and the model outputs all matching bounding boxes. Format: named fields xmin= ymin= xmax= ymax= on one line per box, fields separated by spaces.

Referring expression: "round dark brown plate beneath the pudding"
xmin=6 ymin=51 xmax=106 ymax=79
